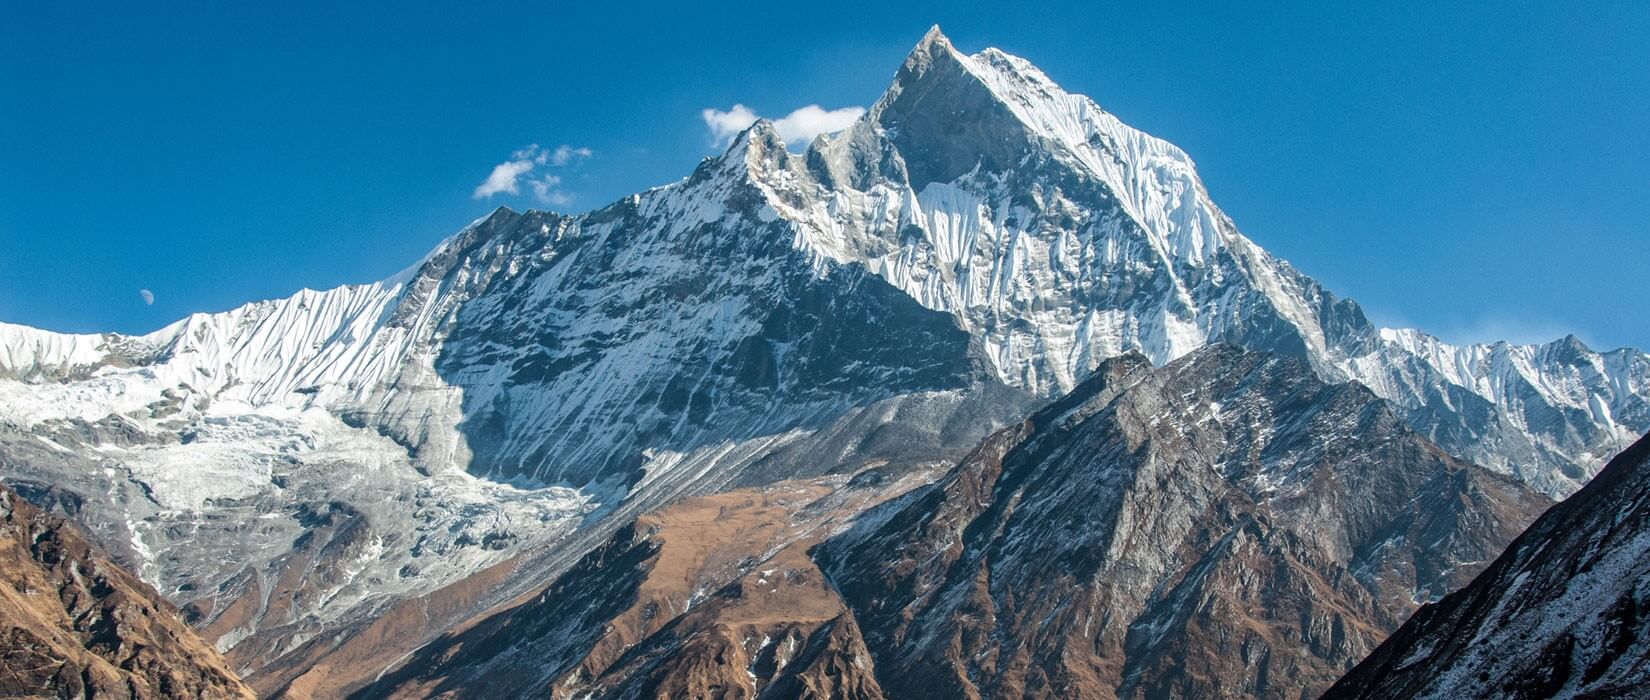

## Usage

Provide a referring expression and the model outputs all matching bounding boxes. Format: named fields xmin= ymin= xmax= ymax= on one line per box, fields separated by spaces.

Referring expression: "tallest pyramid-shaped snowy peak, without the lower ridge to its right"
xmin=757 ymin=33 xmax=1306 ymax=387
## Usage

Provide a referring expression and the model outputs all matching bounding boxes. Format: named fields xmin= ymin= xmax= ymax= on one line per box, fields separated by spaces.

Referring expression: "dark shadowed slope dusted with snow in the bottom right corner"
xmin=1323 ymin=436 xmax=1650 ymax=698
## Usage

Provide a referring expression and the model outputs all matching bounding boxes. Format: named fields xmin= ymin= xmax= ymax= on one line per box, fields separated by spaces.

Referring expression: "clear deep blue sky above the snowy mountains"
xmin=0 ymin=2 xmax=1650 ymax=347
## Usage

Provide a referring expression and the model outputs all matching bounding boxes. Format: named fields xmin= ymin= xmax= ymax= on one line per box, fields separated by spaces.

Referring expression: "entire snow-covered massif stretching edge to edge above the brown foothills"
xmin=0 ymin=30 xmax=1650 ymax=683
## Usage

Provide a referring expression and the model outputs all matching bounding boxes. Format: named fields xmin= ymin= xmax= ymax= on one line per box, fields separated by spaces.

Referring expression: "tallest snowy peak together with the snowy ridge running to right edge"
xmin=756 ymin=30 xmax=1650 ymax=494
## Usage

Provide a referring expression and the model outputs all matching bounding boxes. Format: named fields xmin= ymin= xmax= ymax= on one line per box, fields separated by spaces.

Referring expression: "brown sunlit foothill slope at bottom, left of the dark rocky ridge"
xmin=356 ymin=469 xmax=924 ymax=698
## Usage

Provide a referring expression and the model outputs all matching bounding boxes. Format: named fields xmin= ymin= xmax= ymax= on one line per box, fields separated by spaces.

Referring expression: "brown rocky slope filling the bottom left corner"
xmin=0 ymin=485 xmax=252 ymax=698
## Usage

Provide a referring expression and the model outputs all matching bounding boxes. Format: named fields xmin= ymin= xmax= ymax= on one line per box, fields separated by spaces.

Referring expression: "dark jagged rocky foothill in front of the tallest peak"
xmin=818 ymin=347 xmax=1549 ymax=698
